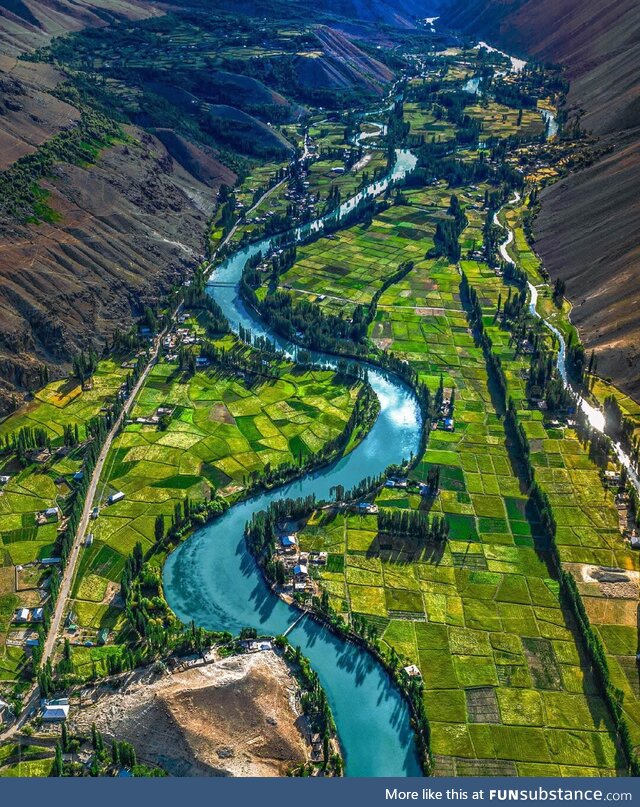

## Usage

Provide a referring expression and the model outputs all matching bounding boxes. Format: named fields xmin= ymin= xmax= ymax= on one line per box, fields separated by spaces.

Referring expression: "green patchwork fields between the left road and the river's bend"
xmin=72 ymin=348 xmax=359 ymax=631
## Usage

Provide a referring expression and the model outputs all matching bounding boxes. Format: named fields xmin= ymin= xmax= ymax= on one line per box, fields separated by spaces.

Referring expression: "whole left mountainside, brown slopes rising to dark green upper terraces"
xmin=0 ymin=0 xmax=436 ymax=415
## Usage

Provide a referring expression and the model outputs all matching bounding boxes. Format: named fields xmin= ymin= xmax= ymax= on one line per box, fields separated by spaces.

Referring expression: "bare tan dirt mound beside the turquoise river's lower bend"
xmin=74 ymin=652 xmax=308 ymax=776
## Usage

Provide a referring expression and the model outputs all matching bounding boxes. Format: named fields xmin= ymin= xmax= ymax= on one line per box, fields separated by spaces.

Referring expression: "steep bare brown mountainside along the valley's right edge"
xmin=444 ymin=0 xmax=640 ymax=397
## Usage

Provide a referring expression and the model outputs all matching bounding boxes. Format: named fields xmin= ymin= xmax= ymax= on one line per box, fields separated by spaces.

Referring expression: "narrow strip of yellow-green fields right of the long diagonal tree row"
xmin=465 ymin=216 xmax=640 ymax=744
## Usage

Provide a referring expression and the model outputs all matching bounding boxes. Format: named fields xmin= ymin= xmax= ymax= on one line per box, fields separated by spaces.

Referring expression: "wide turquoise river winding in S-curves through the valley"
xmin=163 ymin=151 xmax=422 ymax=776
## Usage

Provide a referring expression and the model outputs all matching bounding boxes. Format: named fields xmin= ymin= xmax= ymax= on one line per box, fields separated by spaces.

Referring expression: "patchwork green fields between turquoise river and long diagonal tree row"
xmin=301 ymin=254 xmax=618 ymax=775
